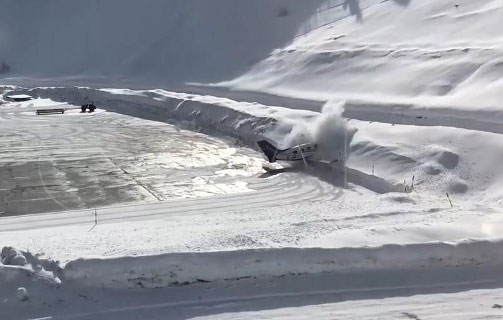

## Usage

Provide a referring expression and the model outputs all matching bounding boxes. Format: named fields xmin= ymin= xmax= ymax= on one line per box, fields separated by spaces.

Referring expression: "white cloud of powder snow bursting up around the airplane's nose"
xmin=284 ymin=101 xmax=354 ymax=162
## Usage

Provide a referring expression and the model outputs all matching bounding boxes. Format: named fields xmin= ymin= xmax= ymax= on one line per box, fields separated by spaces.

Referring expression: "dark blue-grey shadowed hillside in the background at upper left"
xmin=0 ymin=0 xmax=323 ymax=85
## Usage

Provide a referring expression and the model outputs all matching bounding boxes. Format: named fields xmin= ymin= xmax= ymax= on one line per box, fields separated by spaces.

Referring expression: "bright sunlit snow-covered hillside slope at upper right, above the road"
xmin=223 ymin=0 xmax=503 ymax=107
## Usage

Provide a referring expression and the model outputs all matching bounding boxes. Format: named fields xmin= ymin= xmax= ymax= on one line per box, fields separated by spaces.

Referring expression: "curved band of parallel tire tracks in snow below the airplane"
xmin=0 ymin=177 xmax=342 ymax=232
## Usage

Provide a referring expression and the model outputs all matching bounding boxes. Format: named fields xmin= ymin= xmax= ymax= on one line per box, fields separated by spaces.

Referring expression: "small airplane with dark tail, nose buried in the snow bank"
xmin=257 ymin=140 xmax=318 ymax=163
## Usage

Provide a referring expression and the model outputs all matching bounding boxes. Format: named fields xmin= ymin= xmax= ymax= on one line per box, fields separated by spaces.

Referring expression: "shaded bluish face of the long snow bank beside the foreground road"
xmin=63 ymin=241 xmax=503 ymax=288
